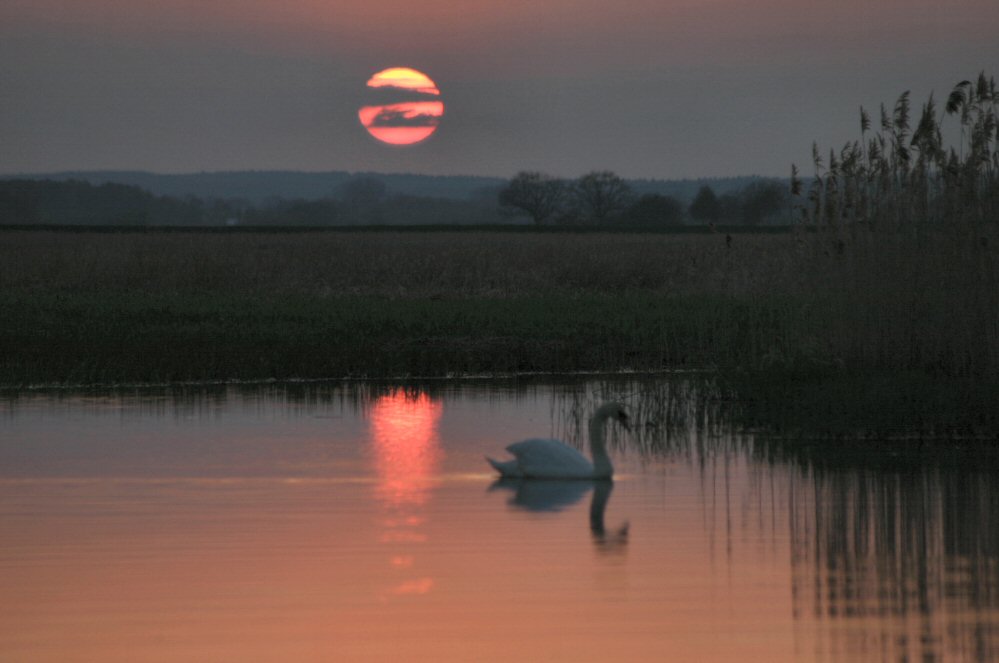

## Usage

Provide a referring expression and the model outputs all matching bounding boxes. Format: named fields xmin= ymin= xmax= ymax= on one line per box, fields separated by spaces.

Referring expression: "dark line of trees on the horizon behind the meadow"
xmin=0 ymin=171 xmax=789 ymax=227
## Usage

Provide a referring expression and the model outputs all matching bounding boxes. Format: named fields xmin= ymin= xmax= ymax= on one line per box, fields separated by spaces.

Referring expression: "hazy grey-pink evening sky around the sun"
xmin=0 ymin=0 xmax=999 ymax=178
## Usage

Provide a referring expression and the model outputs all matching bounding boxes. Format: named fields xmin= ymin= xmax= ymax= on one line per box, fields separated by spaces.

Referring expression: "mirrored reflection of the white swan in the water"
xmin=489 ymin=478 xmax=628 ymax=553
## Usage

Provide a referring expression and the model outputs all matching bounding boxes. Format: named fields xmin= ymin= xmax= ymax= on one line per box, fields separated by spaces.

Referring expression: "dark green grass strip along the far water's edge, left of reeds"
xmin=0 ymin=292 xmax=796 ymax=385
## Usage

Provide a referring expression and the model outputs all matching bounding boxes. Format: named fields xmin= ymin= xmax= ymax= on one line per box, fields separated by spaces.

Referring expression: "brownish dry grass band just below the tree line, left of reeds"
xmin=0 ymin=231 xmax=795 ymax=298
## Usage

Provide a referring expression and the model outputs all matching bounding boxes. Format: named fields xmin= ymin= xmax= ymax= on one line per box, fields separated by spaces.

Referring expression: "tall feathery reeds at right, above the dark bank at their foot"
xmin=791 ymin=73 xmax=999 ymax=378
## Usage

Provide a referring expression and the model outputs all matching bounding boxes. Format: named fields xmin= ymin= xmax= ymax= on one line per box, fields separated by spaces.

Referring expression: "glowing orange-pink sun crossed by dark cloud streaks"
xmin=357 ymin=67 xmax=444 ymax=145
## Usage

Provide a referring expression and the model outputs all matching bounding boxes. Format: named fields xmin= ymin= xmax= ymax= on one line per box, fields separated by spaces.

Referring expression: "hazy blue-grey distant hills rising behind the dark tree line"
xmin=0 ymin=170 xmax=763 ymax=205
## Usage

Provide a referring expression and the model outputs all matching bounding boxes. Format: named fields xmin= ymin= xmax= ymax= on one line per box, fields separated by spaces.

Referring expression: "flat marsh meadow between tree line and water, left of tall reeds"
xmin=0 ymin=232 xmax=791 ymax=385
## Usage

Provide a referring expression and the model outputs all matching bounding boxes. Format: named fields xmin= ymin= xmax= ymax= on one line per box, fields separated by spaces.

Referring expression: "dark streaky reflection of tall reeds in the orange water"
xmin=790 ymin=468 xmax=999 ymax=661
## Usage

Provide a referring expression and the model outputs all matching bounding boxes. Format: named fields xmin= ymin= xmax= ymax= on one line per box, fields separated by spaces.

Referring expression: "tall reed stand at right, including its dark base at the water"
xmin=726 ymin=74 xmax=999 ymax=440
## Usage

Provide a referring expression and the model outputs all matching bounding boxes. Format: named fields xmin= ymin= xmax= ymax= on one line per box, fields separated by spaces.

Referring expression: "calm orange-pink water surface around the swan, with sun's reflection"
xmin=0 ymin=383 xmax=999 ymax=662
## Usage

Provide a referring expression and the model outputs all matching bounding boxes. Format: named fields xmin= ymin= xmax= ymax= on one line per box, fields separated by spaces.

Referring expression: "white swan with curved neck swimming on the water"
xmin=486 ymin=403 xmax=628 ymax=479
